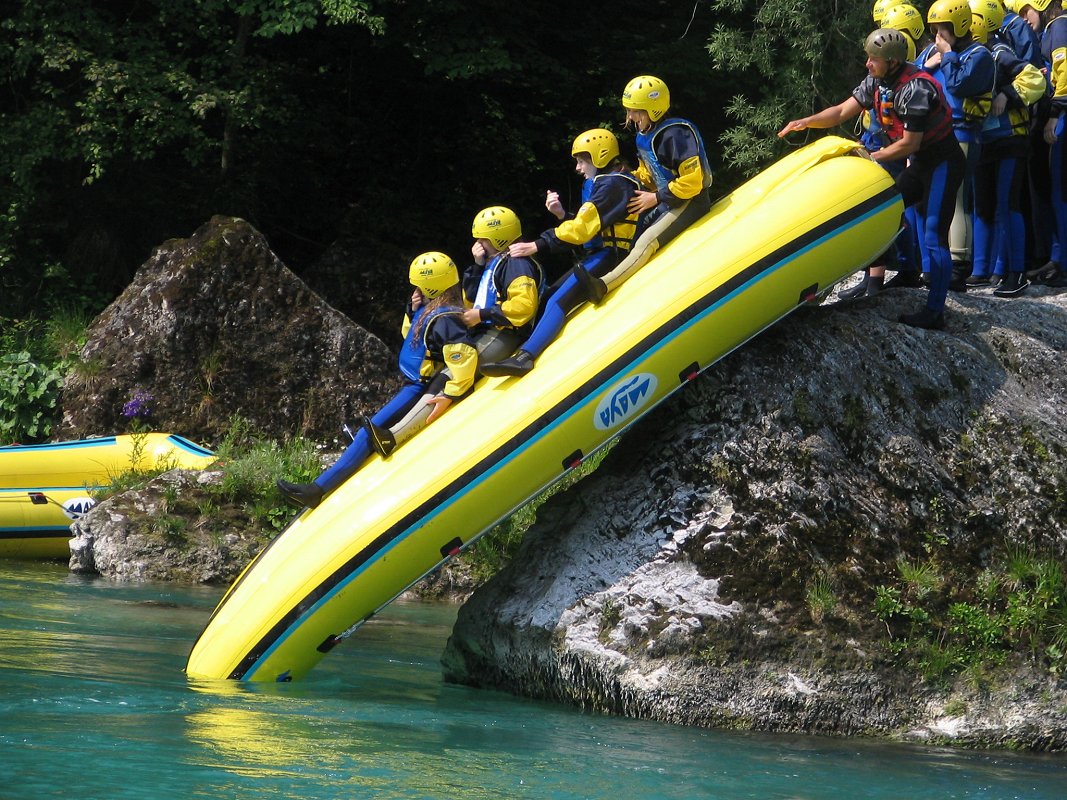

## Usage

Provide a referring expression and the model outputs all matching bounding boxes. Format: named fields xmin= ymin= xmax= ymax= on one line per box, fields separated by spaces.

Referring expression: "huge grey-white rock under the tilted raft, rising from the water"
xmin=443 ymin=290 xmax=1067 ymax=748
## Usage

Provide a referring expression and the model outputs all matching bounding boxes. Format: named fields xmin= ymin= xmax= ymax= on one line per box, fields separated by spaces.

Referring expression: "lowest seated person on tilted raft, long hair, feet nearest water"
xmin=277 ymin=252 xmax=478 ymax=508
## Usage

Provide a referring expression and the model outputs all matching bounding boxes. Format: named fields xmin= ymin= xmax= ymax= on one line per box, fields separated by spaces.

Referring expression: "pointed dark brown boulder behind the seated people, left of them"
xmin=59 ymin=217 xmax=403 ymax=439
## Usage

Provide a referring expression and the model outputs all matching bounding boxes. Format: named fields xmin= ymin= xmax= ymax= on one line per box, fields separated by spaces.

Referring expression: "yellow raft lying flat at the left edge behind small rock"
xmin=0 ymin=433 xmax=214 ymax=559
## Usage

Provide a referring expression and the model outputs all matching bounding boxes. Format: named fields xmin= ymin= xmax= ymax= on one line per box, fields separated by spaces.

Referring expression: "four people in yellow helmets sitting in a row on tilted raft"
xmin=277 ymin=76 xmax=712 ymax=508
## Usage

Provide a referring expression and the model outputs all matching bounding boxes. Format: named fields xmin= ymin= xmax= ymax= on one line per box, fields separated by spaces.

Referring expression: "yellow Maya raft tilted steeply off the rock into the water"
xmin=187 ymin=137 xmax=903 ymax=681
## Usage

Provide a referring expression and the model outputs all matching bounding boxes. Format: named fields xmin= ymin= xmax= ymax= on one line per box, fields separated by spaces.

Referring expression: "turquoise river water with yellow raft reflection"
xmin=0 ymin=563 xmax=1067 ymax=800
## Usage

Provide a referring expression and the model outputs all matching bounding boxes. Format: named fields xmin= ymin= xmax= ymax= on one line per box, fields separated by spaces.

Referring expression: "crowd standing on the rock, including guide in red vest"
xmin=778 ymin=0 xmax=1067 ymax=329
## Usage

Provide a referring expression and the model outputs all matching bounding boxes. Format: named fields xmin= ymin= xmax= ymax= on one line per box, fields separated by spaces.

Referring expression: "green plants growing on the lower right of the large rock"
xmin=874 ymin=548 xmax=1067 ymax=683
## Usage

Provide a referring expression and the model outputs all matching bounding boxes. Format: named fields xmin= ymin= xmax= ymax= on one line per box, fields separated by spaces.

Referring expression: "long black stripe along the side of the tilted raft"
xmin=227 ymin=188 xmax=898 ymax=681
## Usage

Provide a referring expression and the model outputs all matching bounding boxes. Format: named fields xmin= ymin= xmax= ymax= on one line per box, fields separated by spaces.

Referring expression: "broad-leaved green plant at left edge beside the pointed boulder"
xmin=0 ymin=350 xmax=63 ymax=444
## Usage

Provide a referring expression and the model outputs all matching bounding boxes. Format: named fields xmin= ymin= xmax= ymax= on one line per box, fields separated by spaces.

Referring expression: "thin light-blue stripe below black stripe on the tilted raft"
xmin=238 ymin=192 xmax=899 ymax=679
